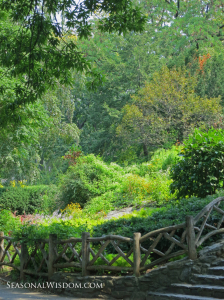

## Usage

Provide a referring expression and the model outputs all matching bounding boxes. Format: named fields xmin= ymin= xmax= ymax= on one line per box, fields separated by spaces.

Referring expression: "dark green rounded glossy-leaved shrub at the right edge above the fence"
xmin=170 ymin=128 xmax=224 ymax=198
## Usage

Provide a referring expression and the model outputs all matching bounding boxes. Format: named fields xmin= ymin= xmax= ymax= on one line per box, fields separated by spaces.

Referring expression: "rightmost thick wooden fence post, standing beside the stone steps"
xmin=186 ymin=216 xmax=197 ymax=260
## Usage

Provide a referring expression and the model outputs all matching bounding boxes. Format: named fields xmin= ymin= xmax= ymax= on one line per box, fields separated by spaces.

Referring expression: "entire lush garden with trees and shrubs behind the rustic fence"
xmin=0 ymin=0 xmax=224 ymax=284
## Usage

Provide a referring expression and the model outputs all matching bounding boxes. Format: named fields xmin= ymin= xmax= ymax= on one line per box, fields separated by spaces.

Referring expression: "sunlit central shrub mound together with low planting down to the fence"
xmin=3 ymin=145 xmax=224 ymax=276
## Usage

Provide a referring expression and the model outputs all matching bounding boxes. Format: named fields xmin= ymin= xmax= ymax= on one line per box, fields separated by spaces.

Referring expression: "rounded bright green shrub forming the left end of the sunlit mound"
xmin=60 ymin=154 xmax=124 ymax=207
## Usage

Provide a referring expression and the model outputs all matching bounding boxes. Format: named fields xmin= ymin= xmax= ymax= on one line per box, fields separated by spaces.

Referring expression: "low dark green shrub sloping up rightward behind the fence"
xmin=93 ymin=191 xmax=224 ymax=253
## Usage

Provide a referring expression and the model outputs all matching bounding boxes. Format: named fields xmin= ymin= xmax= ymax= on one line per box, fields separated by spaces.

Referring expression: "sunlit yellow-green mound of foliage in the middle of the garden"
xmin=60 ymin=147 xmax=178 ymax=213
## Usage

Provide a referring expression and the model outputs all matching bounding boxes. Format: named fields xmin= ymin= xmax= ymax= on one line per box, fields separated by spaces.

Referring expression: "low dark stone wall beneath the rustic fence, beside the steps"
xmin=51 ymin=241 xmax=224 ymax=300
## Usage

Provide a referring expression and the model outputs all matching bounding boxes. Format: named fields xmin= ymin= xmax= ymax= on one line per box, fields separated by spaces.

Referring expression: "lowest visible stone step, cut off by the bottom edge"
xmin=146 ymin=292 xmax=223 ymax=300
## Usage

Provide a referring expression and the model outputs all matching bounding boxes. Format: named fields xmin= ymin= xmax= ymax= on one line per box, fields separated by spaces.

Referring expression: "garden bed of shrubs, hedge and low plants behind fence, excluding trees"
xmin=0 ymin=128 xmax=224 ymax=275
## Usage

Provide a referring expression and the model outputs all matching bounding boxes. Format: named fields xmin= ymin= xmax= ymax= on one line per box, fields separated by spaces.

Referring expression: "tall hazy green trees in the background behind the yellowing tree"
xmin=73 ymin=0 xmax=223 ymax=160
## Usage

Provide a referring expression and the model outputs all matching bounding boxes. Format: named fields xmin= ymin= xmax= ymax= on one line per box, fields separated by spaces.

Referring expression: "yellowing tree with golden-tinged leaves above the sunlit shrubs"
xmin=117 ymin=67 xmax=221 ymax=156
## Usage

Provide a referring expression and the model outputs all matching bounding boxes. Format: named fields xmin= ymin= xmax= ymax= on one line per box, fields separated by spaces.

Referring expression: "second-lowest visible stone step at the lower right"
xmin=169 ymin=283 xmax=224 ymax=299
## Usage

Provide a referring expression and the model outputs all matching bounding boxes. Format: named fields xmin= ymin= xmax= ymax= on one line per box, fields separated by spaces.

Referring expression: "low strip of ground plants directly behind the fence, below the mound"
xmin=7 ymin=191 xmax=224 ymax=274
